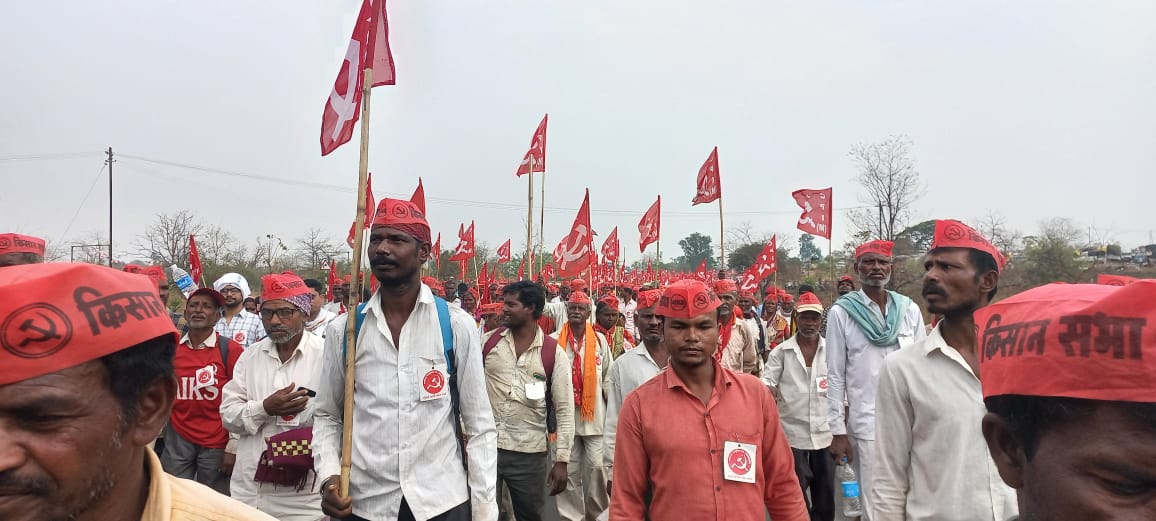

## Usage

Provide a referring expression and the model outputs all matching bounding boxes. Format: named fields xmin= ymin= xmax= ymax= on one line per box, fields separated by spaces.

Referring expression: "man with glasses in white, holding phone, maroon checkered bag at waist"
xmin=221 ymin=273 xmax=323 ymax=521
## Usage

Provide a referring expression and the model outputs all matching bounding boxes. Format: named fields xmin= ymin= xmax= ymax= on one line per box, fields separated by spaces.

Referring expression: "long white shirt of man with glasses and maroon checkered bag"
xmin=221 ymin=332 xmax=324 ymax=516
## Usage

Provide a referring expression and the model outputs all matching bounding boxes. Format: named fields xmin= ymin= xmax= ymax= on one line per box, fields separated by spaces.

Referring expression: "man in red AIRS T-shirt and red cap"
xmin=161 ymin=288 xmax=242 ymax=493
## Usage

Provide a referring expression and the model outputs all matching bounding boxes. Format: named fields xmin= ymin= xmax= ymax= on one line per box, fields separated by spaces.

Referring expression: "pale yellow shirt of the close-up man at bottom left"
xmin=141 ymin=451 xmax=276 ymax=521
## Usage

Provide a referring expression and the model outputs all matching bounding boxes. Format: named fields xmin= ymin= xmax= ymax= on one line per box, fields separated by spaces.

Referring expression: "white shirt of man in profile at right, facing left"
xmin=867 ymin=327 xmax=1018 ymax=521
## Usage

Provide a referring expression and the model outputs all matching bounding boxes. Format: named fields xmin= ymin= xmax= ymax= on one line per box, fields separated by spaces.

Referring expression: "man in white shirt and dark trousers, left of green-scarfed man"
xmin=763 ymin=293 xmax=835 ymax=521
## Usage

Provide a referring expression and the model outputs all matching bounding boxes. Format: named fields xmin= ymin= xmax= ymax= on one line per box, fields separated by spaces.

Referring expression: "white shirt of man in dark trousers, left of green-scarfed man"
xmin=763 ymin=335 xmax=831 ymax=451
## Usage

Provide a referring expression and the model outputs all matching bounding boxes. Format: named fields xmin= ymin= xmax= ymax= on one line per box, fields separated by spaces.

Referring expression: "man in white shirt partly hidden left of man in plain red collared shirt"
xmin=602 ymin=290 xmax=670 ymax=491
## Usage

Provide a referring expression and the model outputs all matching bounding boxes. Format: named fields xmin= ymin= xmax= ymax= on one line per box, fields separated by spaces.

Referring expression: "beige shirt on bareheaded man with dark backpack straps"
xmin=482 ymin=328 xmax=575 ymax=462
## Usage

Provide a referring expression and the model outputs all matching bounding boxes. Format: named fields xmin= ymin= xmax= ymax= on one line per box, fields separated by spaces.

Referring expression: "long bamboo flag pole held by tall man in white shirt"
xmin=340 ymin=67 xmax=373 ymax=497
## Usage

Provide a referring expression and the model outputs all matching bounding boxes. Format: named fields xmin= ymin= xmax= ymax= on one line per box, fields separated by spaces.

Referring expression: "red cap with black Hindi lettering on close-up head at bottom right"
xmin=976 ymin=281 xmax=1156 ymax=403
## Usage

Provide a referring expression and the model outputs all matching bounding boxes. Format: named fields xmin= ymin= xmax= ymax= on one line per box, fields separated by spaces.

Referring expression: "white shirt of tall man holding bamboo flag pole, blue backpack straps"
xmin=313 ymin=284 xmax=498 ymax=521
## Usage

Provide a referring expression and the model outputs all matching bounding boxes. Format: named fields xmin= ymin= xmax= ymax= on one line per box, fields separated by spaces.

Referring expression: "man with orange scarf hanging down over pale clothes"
xmin=551 ymin=291 xmax=612 ymax=521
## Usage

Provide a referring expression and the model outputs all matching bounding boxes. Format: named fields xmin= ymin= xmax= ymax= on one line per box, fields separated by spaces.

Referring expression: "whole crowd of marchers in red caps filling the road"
xmin=0 ymin=207 xmax=1156 ymax=521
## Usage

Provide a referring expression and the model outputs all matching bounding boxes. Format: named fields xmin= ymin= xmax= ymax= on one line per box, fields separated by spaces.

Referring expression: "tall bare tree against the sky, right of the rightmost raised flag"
xmin=847 ymin=135 xmax=924 ymax=240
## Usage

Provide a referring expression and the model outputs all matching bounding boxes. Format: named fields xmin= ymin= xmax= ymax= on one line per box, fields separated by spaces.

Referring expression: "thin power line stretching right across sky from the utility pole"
xmin=117 ymin=154 xmax=868 ymax=217
